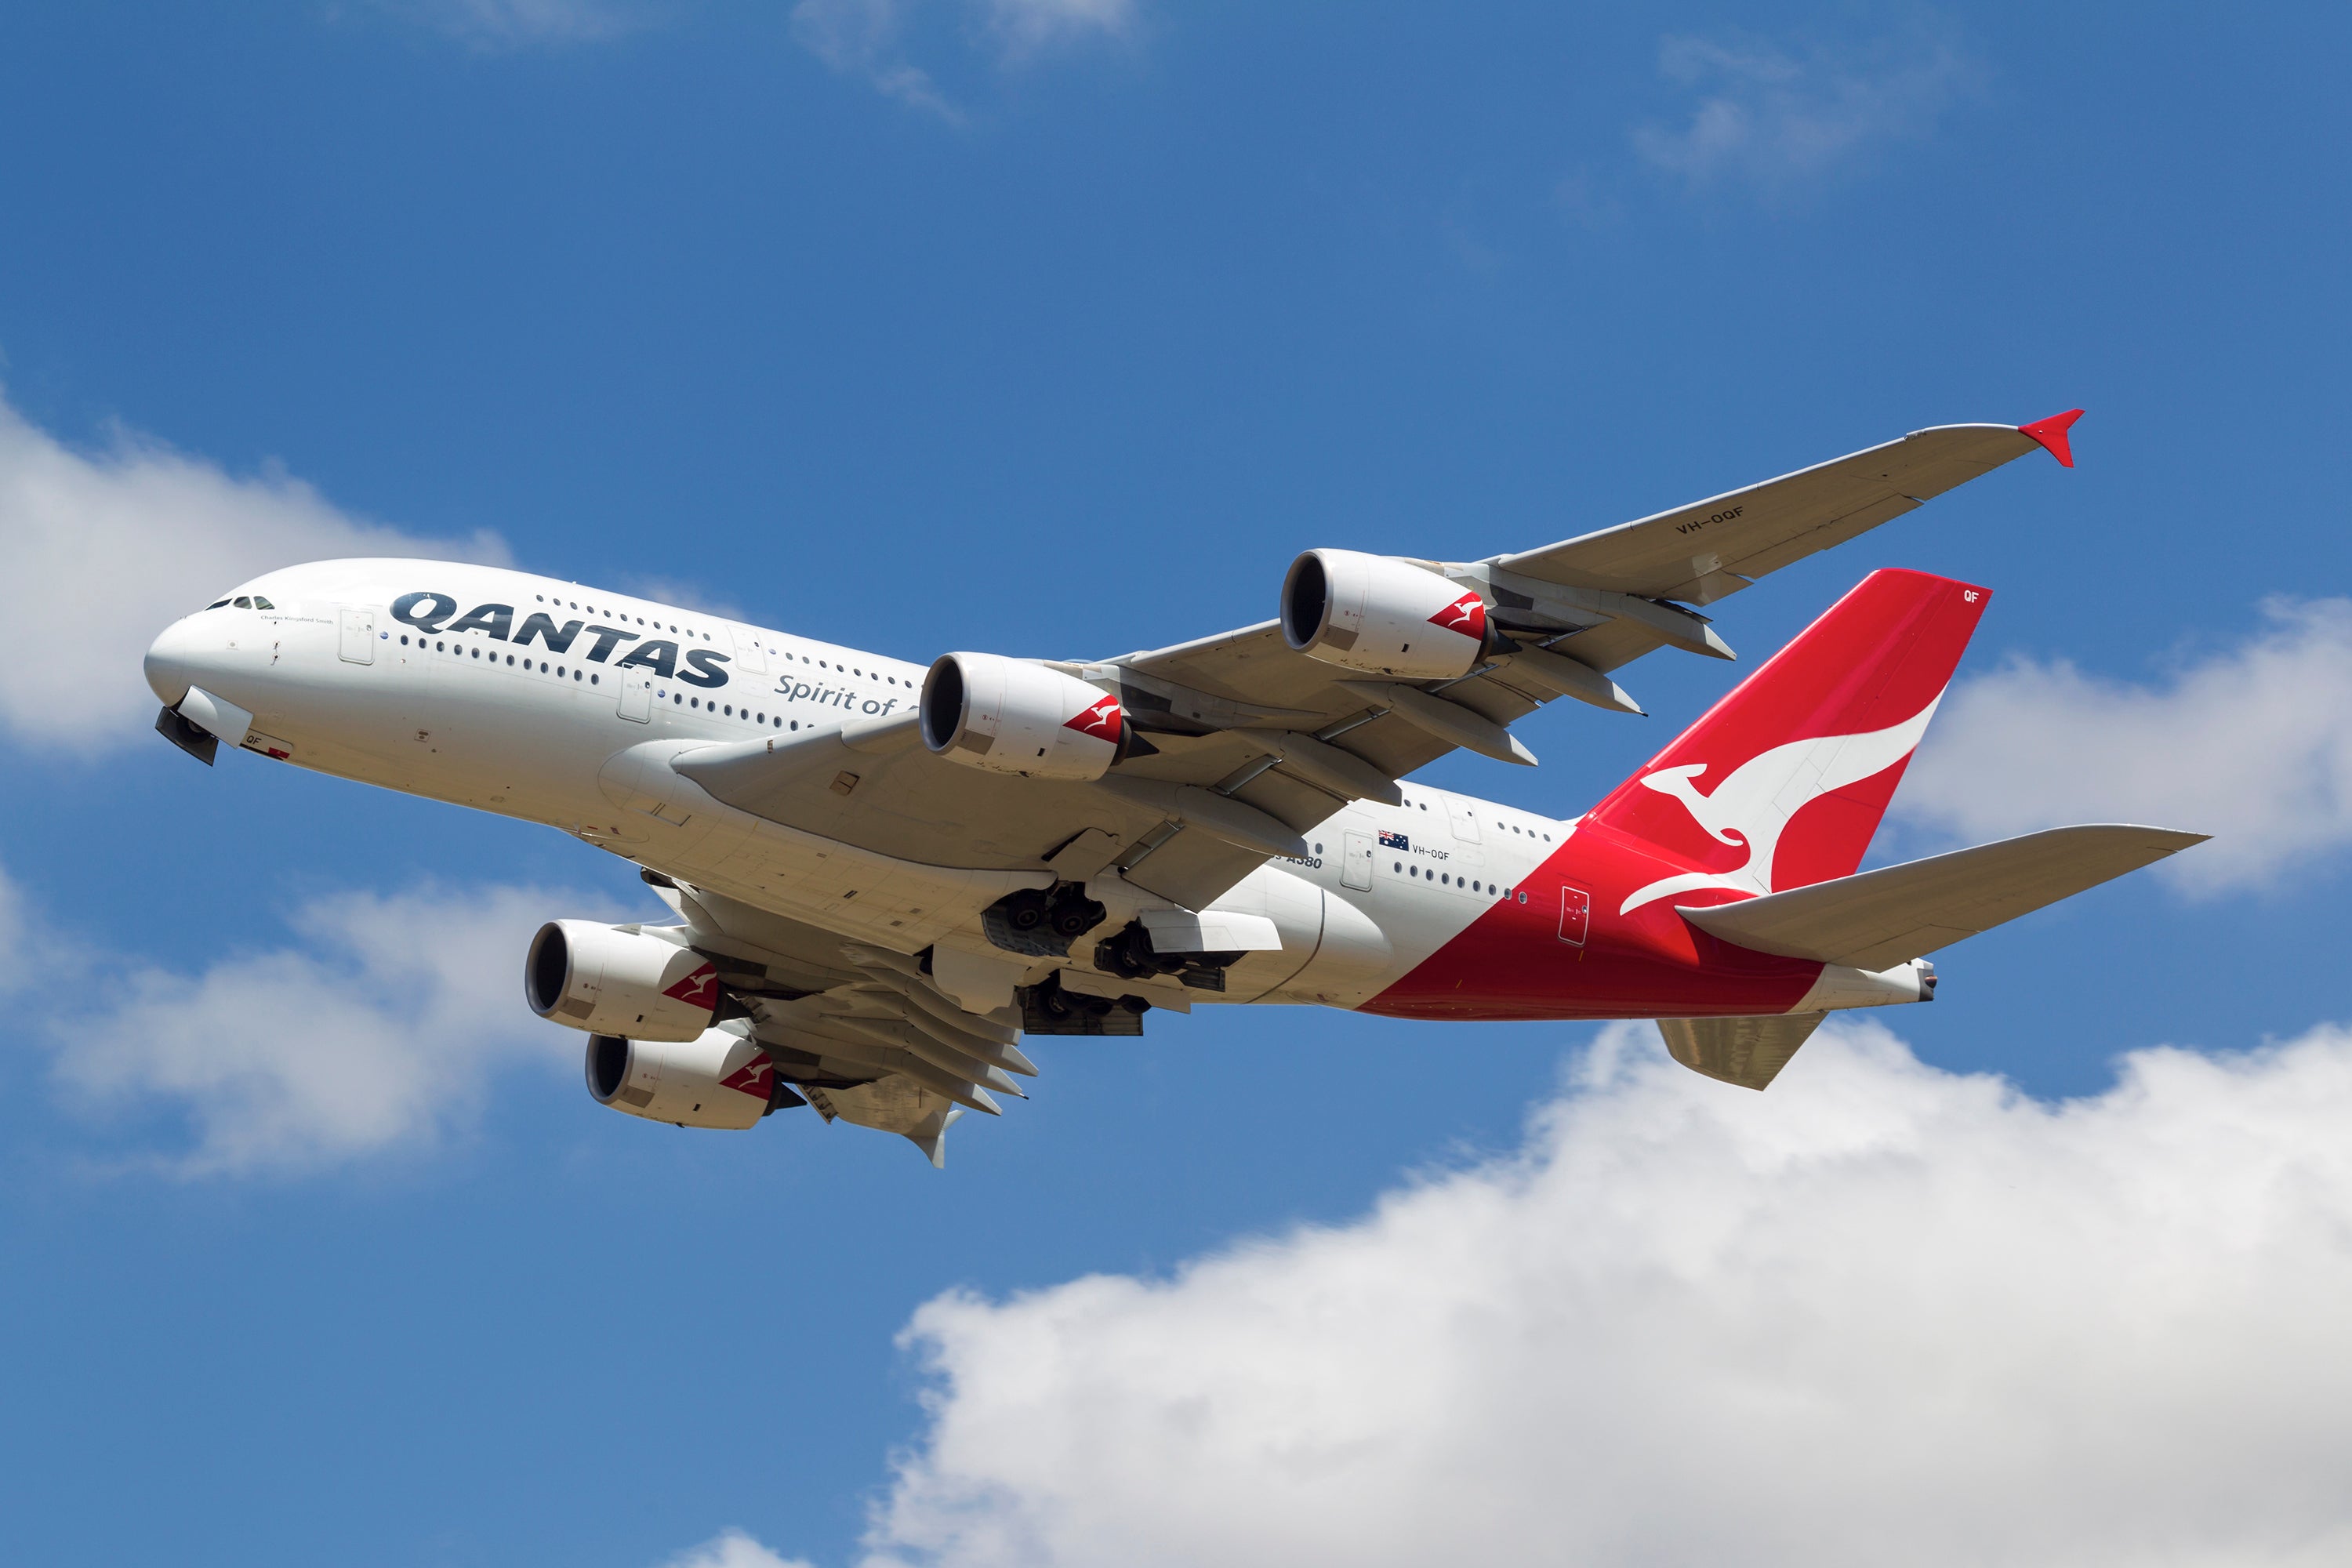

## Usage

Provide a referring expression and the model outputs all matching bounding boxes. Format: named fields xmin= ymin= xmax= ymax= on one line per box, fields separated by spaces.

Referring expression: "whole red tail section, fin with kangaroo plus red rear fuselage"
xmin=1364 ymin=572 xmax=1990 ymax=1018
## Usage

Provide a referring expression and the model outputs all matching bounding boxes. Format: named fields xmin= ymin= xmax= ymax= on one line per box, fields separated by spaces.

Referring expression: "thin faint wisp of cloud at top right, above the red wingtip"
xmin=1635 ymin=26 xmax=1973 ymax=191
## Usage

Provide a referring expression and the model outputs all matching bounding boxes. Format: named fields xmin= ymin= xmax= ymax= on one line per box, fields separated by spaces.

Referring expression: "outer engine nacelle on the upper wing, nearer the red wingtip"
xmin=1282 ymin=550 xmax=1486 ymax=680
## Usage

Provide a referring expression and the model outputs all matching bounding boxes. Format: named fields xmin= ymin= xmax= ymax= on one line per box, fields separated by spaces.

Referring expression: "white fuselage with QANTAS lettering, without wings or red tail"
xmin=148 ymin=560 xmax=1573 ymax=1006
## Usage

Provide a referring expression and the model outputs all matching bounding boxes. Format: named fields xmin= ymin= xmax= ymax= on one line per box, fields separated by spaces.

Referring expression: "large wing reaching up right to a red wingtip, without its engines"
xmin=675 ymin=416 xmax=2070 ymax=909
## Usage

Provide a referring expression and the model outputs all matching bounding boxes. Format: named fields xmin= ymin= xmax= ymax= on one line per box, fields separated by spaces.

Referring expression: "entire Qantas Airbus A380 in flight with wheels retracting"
xmin=146 ymin=409 xmax=2201 ymax=1163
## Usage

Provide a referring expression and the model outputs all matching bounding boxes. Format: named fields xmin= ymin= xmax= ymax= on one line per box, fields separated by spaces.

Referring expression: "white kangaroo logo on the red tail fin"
xmin=1618 ymin=691 xmax=1943 ymax=914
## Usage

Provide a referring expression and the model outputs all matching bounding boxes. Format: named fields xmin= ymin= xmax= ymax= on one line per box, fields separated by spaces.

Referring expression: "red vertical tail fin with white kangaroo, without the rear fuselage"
xmin=1585 ymin=572 xmax=1992 ymax=909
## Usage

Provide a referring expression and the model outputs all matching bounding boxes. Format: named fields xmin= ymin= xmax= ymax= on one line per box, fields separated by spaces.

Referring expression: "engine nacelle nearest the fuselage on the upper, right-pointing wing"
xmin=922 ymin=654 xmax=1129 ymax=781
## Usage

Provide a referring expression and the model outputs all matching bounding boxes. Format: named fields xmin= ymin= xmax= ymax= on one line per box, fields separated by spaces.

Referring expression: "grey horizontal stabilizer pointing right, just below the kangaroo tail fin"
xmin=1679 ymin=822 xmax=2209 ymax=968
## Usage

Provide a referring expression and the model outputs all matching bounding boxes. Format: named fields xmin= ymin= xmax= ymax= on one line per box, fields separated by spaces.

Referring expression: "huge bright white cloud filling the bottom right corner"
xmin=870 ymin=1022 xmax=2352 ymax=1568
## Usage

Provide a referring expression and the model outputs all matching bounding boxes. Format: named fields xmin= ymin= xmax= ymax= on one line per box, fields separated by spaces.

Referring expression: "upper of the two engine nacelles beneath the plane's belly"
xmin=522 ymin=919 xmax=720 ymax=1041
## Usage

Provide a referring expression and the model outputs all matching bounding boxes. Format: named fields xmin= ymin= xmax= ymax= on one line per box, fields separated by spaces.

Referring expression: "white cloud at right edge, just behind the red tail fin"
xmin=1896 ymin=600 xmax=2352 ymax=891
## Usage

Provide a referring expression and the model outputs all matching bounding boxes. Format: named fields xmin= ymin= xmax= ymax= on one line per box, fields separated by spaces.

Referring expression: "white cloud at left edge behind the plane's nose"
xmin=0 ymin=397 xmax=506 ymax=755
